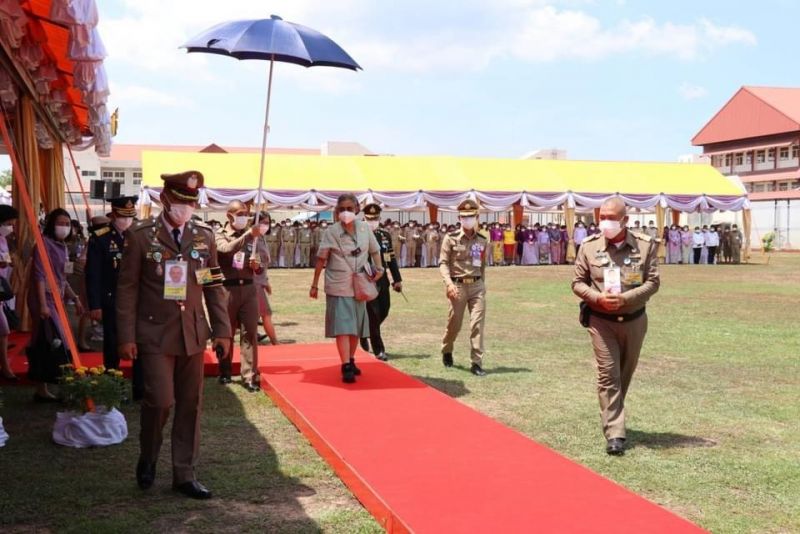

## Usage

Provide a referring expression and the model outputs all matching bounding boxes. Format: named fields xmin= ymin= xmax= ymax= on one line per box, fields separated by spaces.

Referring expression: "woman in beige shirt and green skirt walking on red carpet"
xmin=309 ymin=193 xmax=383 ymax=383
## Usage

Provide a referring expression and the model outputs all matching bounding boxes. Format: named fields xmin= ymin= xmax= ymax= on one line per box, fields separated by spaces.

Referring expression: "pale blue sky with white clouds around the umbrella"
xmin=6 ymin=0 xmax=800 ymax=168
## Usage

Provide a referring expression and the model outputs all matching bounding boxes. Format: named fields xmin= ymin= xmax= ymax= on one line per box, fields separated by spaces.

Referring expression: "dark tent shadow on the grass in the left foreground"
xmin=0 ymin=379 xmax=321 ymax=532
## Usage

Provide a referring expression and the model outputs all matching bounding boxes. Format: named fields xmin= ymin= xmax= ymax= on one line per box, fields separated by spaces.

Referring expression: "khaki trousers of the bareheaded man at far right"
xmin=587 ymin=314 xmax=647 ymax=439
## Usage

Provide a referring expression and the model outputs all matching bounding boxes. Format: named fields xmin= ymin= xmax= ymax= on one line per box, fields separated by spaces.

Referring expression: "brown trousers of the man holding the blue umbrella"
xmin=225 ymin=284 xmax=259 ymax=384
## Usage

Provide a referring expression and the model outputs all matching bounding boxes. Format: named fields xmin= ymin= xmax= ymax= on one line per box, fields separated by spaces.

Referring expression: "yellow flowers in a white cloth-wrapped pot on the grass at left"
xmin=53 ymin=365 xmax=128 ymax=447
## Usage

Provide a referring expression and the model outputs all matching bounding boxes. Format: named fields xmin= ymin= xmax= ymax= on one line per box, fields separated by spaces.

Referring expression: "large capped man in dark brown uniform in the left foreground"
xmin=117 ymin=171 xmax=231 ymax=499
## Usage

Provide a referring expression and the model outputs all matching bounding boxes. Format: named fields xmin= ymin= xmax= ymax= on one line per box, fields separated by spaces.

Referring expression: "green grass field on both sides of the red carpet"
xmin=0 ymin=255 xmax=800 ymax=533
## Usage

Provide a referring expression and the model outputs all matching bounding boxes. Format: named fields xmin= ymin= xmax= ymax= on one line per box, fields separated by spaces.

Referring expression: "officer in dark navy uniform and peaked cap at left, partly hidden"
xmin=86 ymin=196 xmax=143 ymax=400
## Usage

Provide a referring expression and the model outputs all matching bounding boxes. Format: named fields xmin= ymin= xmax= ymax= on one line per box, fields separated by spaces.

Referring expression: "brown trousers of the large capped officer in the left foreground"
xmin=139 ymin=352 xmax=203 ymax=484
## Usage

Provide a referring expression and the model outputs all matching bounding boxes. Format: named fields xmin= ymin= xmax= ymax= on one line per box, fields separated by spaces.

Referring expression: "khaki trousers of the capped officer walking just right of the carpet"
xmin=442 ymin=280 xmax=486 ymax=365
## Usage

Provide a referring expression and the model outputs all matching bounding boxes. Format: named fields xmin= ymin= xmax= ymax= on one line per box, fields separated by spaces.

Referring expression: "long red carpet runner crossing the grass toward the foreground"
xmin=261 ymin=343 xmax=702 ymax=534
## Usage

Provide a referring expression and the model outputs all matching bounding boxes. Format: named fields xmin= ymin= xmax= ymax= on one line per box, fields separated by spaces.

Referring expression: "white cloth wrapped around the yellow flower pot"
xmin=53 ymin=408 xmax=128 ymax=448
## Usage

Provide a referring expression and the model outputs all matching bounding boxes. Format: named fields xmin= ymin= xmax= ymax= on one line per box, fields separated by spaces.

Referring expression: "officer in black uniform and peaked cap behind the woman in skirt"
xmin=361 ymin=203 xmax=403 ymax=361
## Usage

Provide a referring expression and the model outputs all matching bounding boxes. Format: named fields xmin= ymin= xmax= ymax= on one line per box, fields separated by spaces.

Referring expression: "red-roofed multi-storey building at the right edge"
xmin=692 ymin=86 xmax=800 ymax=248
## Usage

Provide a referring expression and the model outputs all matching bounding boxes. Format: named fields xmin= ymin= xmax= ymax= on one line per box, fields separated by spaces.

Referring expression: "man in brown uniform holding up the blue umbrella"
xmin=216 ymin=200 xmax=269 ymax=393
